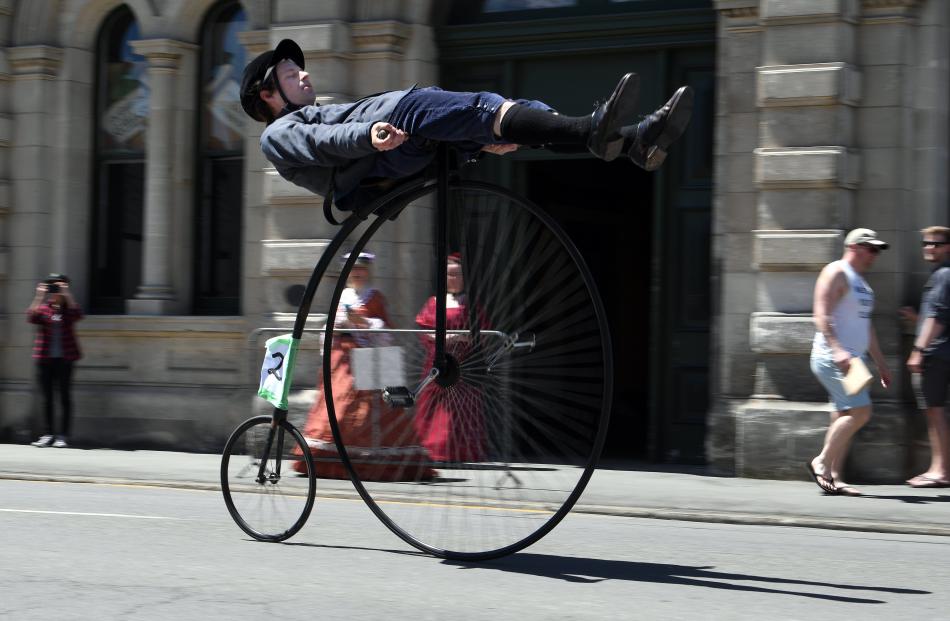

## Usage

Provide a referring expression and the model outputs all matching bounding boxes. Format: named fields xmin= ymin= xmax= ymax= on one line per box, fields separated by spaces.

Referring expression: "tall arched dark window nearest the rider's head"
xmin=194 ymin=2 xmax=247 ymax=315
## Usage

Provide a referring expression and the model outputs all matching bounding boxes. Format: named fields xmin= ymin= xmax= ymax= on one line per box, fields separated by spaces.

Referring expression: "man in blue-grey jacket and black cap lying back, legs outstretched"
xmin=241 ymin=39 xmax=693 ymax=209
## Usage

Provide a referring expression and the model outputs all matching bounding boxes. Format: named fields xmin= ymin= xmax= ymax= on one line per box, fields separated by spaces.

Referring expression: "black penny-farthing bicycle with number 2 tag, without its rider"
xmin=221 ymin=138 xmax=612 ymax=560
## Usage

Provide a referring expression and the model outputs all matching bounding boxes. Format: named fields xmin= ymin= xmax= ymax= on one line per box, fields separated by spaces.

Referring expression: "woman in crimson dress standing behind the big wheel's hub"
xmin=415 ymin=253 xmax=486 ymax=462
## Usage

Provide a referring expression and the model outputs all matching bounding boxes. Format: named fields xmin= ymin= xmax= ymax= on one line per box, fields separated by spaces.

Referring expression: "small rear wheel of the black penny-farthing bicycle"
xmin=221 ymin=416 xmax=317 ymax=541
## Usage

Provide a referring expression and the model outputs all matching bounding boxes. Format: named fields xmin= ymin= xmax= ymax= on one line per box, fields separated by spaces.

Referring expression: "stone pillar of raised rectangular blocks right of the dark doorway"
xmin=748 ymin=0 xmax=861 ymax=478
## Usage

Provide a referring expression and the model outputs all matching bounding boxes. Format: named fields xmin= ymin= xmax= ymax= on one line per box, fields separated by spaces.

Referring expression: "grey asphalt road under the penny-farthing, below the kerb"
xmin=0 ymin=481 xmax=950 ymax=621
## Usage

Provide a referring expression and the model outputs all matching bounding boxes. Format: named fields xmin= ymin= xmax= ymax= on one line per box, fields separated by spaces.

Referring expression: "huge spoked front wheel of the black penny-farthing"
xmin=323 ymin=182 xmax=612 ymax=559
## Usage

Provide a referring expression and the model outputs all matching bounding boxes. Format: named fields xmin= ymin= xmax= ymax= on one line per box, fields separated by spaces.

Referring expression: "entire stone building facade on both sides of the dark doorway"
xmin=0 ymin=0 xmax=950 ymax=481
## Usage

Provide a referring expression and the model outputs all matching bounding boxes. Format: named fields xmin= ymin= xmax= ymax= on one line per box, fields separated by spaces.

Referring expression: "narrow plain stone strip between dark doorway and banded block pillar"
xmin=706 ymin=0 xmax=762 ymax=474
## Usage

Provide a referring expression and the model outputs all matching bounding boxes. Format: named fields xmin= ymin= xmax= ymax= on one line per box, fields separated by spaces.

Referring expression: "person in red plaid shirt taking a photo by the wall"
xmin=26 ymin=274 xmax=82 ymax=448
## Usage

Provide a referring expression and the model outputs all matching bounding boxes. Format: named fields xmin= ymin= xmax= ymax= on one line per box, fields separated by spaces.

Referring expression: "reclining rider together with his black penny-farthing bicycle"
xmin=222 ymin=39 xmax=693 ymax=558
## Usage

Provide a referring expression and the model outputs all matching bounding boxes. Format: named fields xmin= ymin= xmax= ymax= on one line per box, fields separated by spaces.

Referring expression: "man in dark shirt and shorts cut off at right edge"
xmin=901 ymin=226 xmax=950 ymax=487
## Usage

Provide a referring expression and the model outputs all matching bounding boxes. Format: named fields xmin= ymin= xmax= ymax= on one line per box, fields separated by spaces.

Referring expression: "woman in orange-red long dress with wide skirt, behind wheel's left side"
xmin=295 ymin=252 xmax=435 ymax=481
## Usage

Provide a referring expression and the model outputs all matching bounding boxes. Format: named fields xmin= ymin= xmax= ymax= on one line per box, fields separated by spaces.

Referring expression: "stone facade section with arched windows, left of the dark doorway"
xmin=0 ymin=0 xmax=436 ymax=451
